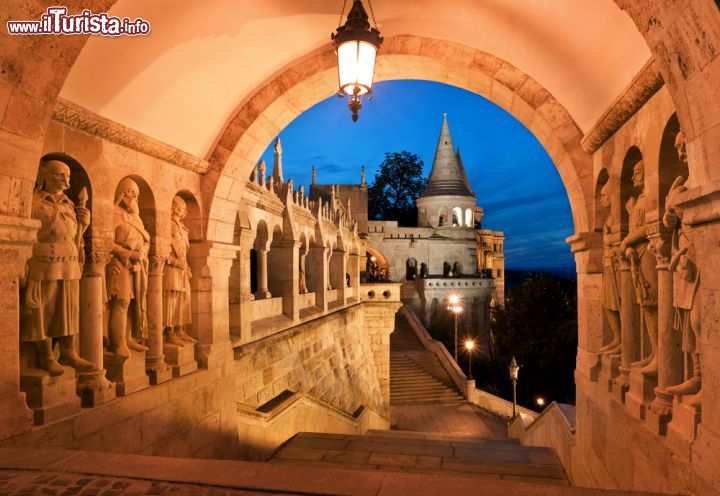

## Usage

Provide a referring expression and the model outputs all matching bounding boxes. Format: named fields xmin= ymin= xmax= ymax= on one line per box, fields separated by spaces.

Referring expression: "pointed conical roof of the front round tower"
xmin=420 ymin=113 xmax=475 ymax=198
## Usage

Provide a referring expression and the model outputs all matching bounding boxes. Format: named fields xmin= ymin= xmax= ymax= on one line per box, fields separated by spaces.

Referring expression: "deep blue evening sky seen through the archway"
xmin=262 ymin=80 xmax=575 ymax=270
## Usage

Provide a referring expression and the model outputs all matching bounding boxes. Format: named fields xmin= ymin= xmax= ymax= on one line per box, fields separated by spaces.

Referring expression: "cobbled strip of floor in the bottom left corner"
xmin=0 ymin=470 xmax=288 ymax=496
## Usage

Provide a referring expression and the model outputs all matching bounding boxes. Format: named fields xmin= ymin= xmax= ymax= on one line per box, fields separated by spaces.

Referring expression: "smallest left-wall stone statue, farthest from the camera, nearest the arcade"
xmin=163 ymin=196 xmax=197 ymax=346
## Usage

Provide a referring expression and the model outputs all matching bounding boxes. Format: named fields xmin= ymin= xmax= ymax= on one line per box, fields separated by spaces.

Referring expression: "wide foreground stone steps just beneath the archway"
xmin=270 ymin=431 xmax=569 ymax=486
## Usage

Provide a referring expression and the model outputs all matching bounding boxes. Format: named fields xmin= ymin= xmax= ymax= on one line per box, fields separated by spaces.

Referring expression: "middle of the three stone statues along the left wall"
xmin=106 ymin=178 xmax=150 ymax=358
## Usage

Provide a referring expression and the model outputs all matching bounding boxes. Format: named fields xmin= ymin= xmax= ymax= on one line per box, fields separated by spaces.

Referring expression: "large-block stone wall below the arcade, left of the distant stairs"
xmin=232 ymin=305 xmax=389 ymax=413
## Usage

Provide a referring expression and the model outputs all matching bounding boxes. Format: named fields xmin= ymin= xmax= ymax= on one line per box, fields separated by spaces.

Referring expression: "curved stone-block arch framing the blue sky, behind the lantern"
xmin=204 ymin=35 xmax=593 ymax=242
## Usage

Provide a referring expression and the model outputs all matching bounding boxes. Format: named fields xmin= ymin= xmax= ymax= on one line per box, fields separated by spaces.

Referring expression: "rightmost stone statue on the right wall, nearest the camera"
xmin=663 ymin=131 xmax=702 ymax=408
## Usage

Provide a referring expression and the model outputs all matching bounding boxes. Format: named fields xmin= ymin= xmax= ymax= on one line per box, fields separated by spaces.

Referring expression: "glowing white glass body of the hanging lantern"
xmin=337 ymin=40 xmax=377 ymax=96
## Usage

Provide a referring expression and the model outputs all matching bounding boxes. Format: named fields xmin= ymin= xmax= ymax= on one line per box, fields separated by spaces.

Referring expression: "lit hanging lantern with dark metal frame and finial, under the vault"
xmin=330 ymin=0 xmax=383 ymax=122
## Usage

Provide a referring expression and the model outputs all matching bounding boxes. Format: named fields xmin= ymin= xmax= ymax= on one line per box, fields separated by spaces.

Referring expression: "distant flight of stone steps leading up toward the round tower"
xmin=390 ymin=314 xmax=465 ymax=405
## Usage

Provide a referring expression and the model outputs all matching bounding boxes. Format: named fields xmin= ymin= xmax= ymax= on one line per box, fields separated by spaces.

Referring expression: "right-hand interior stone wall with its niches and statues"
xmin=572 ymin=87 xmax=720 ymax=494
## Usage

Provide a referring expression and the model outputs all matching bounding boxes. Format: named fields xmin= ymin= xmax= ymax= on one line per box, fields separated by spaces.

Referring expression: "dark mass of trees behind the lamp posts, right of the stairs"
xmin=490 ymin=272 xmax=577 ymax=408
